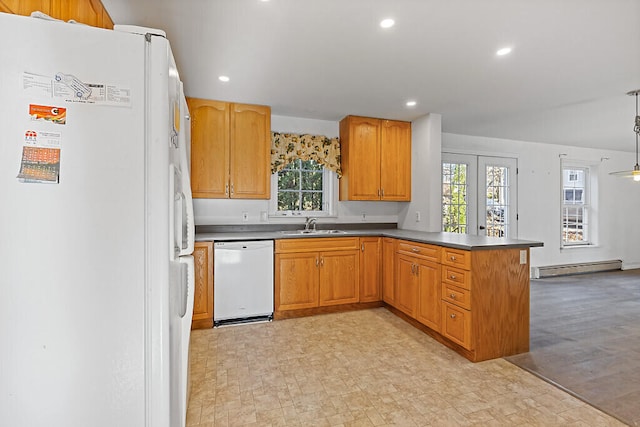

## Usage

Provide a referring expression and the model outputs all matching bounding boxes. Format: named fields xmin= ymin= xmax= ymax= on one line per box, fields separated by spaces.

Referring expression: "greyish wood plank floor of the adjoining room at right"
xmin=508 ymin=270 xmax=640 ymax=426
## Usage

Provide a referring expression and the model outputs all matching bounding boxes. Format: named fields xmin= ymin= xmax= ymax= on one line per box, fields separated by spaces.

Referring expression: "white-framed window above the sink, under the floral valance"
xmin=271 ymin=159 xmax=335 ymax=216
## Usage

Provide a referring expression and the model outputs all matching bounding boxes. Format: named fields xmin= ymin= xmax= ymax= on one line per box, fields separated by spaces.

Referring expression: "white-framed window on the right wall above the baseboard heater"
xmin=562 ymin=166 xmax=591 ymax=246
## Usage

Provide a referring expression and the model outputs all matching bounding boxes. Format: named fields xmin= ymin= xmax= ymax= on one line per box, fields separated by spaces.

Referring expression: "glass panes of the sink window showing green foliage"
xmin=278 ymin=159 xmax=323 ymax=211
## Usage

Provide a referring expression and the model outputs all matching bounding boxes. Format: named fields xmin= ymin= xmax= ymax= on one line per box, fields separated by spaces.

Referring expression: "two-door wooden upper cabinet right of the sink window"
xmin=340 ymin=116 xmax=411 ymax=201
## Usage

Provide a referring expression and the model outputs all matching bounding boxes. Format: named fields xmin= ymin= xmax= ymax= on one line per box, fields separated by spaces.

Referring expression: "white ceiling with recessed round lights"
xmin=103 ymin=0 xmax=640 ymax=151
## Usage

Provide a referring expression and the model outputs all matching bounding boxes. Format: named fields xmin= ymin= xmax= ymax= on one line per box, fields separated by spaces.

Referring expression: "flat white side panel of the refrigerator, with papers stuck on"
xmin=0 ymin=13 xmax=149 ymax=427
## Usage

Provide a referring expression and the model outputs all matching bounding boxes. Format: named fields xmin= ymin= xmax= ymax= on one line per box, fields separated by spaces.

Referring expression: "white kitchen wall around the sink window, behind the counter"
xmin=194 ymin=115 xmax=400 ymax=225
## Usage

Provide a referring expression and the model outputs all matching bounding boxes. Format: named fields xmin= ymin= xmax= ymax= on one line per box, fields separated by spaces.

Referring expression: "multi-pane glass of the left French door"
xmin=442 ymin=162 xmax=468 ymax=234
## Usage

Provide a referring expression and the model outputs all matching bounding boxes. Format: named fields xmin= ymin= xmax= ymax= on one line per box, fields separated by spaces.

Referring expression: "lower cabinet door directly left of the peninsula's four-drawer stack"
xmin=416 ymin=261 xmax=442 ymax=332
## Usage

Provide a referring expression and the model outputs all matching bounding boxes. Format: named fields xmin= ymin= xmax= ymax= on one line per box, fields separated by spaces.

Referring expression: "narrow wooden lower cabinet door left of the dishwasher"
xmin=191 ymin=242 xmax=213 ymax=329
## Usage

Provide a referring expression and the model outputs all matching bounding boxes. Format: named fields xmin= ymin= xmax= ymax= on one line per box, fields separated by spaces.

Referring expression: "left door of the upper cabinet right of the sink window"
xmin=340 ymin=116 xmax=380 ymax=200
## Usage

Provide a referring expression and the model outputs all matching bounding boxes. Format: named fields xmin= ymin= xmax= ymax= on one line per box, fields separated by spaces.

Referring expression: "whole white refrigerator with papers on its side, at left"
xmin=0 ymin=13 xmax=194 ymax=427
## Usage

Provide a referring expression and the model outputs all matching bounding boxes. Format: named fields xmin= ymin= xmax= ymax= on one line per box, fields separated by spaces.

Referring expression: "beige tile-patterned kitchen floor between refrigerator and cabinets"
xmin=187 ymin=308 xmax=623 ymax=427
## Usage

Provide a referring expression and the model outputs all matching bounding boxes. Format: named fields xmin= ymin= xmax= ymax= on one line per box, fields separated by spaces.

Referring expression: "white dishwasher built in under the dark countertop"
xmin=213 ymin=240 xmax=273 ymax=326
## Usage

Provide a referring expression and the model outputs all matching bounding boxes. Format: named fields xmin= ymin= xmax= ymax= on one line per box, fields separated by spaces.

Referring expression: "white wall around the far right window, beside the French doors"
xmin=442 ymin=133 xmax=640 ymax=268
